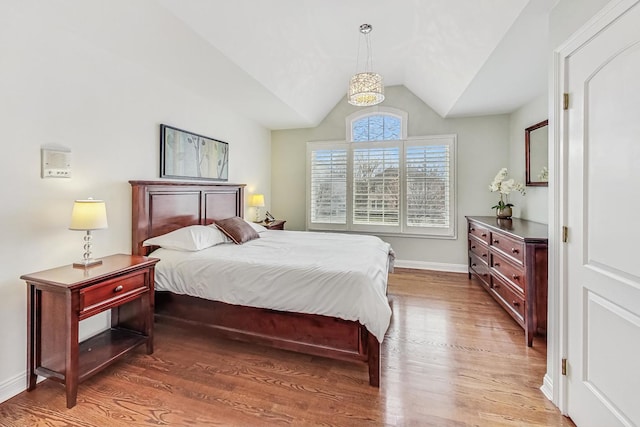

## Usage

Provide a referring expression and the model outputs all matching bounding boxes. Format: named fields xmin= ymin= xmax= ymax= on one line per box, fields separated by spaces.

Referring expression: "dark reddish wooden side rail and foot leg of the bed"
xmin=155 ymin=292 xmax=380 ymax=387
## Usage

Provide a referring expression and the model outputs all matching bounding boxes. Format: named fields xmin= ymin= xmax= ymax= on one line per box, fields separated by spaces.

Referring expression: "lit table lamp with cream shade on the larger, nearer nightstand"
xmin=69 ymin=198 xmax=107 ymax=268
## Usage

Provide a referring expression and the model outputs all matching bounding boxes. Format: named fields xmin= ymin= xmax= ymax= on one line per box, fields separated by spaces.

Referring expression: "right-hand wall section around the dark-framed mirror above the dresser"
xmin=509 ymin=94 xmax=549 ymax=224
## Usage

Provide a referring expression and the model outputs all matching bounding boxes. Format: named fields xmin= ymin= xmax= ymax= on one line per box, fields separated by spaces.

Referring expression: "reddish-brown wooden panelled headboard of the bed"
xmin=129 ymin=181 xmax=245 ymax=255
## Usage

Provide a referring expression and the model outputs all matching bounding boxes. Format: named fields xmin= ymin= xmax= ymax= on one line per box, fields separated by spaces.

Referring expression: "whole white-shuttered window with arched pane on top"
xmin=307 ymin=108 xmax=456 ymax=237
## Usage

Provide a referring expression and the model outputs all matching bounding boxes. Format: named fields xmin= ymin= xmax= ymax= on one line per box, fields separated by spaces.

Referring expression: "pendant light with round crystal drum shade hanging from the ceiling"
xmin=347 ymin=24 xmax=384 ymax=107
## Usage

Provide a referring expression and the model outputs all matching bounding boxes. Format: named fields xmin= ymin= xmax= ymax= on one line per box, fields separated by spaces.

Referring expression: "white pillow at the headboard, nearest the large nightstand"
xmin=142 ymin=225 xmax=228 ymax=252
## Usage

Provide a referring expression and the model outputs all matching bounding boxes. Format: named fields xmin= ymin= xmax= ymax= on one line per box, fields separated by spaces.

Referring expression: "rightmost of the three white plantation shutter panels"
xmin=405 ymin=138 xmax=453 ymax=229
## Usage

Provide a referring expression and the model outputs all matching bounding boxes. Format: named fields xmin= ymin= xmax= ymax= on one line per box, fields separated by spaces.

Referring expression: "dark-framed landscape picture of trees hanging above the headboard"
xmin=160 ymin=125 xmax=229 ymax=181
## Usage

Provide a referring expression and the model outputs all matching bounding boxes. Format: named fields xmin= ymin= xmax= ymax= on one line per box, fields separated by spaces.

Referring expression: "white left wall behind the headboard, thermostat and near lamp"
xmin=0 ymin=1 xmax=271 ymax=401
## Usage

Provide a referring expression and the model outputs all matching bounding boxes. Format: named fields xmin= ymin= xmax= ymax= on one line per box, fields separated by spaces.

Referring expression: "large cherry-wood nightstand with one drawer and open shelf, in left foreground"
xmin=20 ymin=254 xmax=159 ymax=408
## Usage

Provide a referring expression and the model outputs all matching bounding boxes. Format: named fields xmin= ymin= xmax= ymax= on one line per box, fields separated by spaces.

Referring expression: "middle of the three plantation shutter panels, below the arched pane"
xmin=352 ymin=141 xmax=401 ymax=227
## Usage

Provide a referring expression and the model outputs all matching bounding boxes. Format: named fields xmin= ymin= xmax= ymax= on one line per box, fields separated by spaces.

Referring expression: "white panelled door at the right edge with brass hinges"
xmin=564 ymin=0 xmax=640 ymax=427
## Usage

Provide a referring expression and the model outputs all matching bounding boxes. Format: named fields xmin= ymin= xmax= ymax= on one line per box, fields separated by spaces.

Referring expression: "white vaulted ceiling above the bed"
xmin=27 ymin=0 xmax=557 ymax=129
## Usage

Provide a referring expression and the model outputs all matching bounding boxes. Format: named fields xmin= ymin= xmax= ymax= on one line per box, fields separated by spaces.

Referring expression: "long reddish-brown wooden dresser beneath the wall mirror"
xmin=467 ymin=216 xmax=548 ymax=347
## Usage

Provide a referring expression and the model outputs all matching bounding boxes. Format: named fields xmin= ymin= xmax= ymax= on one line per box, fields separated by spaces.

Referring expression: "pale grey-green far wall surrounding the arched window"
xmin=271 ymin=86 xmax=510 ymax=270
